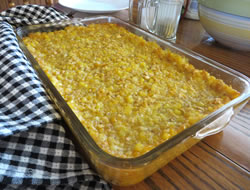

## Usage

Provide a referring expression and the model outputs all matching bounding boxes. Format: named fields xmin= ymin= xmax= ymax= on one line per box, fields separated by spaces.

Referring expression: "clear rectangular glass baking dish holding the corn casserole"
xmin=16 ymin=16 xmax=250 ymax=186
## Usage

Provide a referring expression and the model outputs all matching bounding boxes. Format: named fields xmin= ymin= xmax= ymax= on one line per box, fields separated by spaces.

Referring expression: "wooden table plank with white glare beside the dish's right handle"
xmin=203 ymin=103 xmax=250 ymax=171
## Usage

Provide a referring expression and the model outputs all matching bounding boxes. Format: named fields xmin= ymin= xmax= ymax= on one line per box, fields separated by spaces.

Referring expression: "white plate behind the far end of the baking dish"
xmin=59 ymin=0 xmax=129 ymax=13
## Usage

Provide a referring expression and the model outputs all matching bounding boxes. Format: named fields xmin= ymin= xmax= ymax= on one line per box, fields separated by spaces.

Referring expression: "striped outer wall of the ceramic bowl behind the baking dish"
xmin=199 ymin=4 xmax=250 ymax=51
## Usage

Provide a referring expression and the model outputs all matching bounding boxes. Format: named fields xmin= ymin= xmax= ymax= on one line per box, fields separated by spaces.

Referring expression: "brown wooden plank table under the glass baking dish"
xmin=53 ymin=5 xmax=250 ymax=190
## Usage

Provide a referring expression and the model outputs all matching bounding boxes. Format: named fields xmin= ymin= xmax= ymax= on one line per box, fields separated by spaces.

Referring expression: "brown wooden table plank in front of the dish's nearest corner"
xmin=114 ymin=142 xmax=250 ymax=190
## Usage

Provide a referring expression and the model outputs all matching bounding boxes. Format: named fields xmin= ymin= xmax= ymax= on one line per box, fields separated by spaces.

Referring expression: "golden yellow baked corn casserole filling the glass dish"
xmin=24 ymin=24 xmax=239 ymax=158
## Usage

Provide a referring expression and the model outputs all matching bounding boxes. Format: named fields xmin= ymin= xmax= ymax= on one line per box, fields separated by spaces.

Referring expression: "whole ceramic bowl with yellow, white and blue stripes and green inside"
xmin=199 ymin=0 xmax=250 ymax=51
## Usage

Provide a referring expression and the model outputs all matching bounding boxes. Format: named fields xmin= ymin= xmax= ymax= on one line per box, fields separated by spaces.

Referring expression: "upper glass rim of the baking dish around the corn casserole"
xmin=16 ymin=16 xmax=250 ymax=168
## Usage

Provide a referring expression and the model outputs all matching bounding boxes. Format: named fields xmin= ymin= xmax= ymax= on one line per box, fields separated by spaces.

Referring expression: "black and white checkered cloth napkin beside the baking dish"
xmin=0 ymin=5 xmax=111 ymax=190
